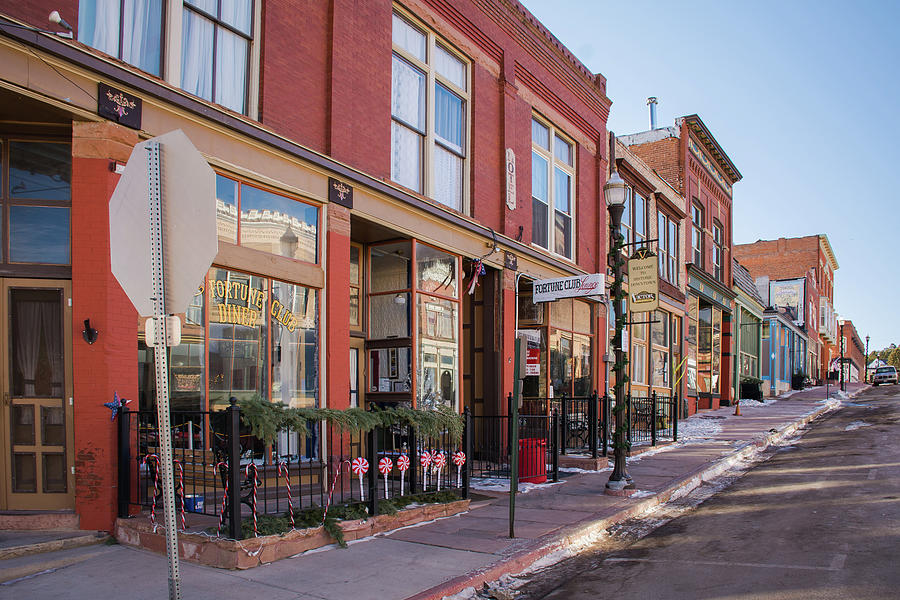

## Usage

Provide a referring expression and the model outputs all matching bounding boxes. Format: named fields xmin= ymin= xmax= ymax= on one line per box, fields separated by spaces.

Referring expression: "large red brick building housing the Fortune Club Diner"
xmin=0 ymin=0 xmax=612 ymax=529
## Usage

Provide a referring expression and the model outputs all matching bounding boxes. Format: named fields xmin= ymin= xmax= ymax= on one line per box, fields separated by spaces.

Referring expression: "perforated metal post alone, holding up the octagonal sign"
xmin=147 ymin=142 xmax=183 ymax=600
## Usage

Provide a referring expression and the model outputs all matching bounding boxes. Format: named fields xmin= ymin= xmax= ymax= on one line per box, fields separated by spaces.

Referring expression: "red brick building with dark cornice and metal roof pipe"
xmin=619 ymin=115 xmax=742 ymax=414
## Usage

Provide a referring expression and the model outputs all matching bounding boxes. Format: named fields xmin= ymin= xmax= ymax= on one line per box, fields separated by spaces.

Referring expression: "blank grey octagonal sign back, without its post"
xmin=109 ymin=129 xmax=219 ymax=316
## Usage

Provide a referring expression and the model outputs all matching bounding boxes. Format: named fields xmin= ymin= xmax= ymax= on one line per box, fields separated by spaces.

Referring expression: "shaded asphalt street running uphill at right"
xmin=517 ymin=385 xmax=900 ymax=600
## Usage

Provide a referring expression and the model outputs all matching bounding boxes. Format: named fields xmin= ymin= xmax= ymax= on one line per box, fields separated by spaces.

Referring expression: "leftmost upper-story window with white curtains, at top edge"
xmin=78 ymin=0 xmax=163 ymax=76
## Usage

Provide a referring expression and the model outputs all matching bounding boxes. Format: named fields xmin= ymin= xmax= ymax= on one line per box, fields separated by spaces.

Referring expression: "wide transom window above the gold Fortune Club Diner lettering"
xmin=216 ymin=174 xmax=319 ymax=263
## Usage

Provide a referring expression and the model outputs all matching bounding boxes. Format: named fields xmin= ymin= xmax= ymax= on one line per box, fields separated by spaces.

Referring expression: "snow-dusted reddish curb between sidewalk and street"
xmin=406 ymin=398 xmax=844 ymax=600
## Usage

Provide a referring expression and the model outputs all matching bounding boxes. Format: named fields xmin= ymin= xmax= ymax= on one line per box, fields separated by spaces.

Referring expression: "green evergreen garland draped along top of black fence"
xmin=238 ymin=396 xmax=463 ymax=444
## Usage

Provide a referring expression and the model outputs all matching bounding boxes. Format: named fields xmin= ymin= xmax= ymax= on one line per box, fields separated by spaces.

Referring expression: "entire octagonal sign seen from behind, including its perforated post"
xmin=109 ymin=130 xmax=214 ymax=600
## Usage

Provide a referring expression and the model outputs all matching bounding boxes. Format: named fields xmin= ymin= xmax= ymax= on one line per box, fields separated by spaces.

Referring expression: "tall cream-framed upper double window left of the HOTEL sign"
xmin=391 ymin=13 xmax=469 ymax=211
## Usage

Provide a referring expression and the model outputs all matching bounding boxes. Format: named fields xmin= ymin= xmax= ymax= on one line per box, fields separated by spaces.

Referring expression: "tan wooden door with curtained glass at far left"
xmin=0 ymin=279 xmax=75 ymax=510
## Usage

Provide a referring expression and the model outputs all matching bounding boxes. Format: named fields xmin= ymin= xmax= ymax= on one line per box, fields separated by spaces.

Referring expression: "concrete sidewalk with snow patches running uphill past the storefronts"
xmin=0 ymin=384 xmax=868 ymax=600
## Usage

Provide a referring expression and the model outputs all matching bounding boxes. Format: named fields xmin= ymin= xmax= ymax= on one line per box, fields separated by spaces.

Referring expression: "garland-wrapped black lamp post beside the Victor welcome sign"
xmin=603 ymin=132 xmax=634 ymax=494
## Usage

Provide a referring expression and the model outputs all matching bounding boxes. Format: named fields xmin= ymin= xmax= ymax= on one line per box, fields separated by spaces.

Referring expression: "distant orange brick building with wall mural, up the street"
xmin=734 ymin=234 xmax=839 ymax=379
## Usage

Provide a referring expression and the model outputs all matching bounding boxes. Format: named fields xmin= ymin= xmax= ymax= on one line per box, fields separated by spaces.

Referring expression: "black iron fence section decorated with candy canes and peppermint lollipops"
xmin=118 ymin=405 xmax=473 ymax=539
